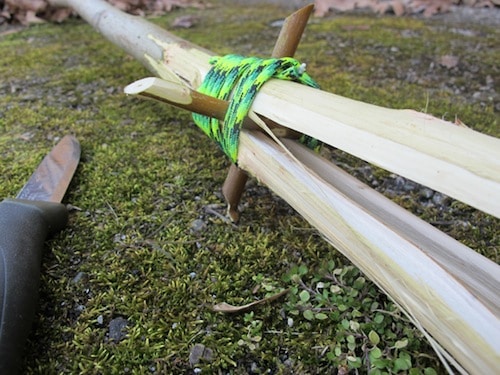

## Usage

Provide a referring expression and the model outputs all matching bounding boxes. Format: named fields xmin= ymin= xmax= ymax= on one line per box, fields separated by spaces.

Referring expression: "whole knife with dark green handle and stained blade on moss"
xmin=0 ymin=135 xmax=80 ymax=374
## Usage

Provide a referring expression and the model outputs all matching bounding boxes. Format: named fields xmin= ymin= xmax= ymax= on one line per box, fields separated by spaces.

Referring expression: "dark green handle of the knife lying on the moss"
xmin=0 ymin=199 xmax=68 ymax=374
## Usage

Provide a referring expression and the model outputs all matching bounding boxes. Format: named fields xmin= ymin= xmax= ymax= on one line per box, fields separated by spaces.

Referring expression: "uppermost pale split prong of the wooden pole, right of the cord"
xmin=253 ymin=80 xmax=500 ymax=217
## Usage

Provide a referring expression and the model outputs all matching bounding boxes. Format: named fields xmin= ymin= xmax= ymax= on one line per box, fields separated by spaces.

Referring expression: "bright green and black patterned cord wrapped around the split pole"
xmin=193 ymin=55 xmax=319 ymax=163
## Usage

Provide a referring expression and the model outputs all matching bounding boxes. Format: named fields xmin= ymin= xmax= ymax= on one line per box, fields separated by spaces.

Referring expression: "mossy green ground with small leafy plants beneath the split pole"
xmin=0 ymin=2 xmax=500 ymax=374
